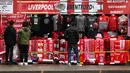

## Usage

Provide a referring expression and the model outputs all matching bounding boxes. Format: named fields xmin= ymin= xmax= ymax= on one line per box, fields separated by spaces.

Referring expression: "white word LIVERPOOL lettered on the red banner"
xmin=28 ymin=4 xmax=54 ymax=10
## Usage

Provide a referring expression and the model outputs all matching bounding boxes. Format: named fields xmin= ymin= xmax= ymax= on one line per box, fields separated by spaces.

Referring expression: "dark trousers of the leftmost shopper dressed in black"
xmin=5 ymin=45 xmax=13 ymax=62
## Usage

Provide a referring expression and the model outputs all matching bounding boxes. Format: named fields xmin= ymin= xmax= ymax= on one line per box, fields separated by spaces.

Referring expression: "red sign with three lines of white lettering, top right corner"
xmin=103 ymin=0 xmax=130 ymax=14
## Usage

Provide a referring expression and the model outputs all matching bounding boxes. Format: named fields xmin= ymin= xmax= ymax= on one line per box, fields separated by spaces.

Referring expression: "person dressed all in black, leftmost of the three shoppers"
xmin=4 ymin=20 xmax=16 ymax=64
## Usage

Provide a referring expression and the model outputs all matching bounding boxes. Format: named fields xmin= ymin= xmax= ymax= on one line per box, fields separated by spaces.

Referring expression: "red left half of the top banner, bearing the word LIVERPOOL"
xmin=17 ymin=1 xmax=58 ymax=14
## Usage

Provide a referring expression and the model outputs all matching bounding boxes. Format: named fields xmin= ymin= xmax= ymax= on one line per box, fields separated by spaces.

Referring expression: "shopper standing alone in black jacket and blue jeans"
xmin=65 ymin=25 xmax=82 ymax=66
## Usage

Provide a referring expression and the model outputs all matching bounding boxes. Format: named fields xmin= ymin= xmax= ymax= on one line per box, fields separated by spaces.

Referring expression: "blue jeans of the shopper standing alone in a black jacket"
xmin=68 ymin=44 xmax=80 ymax=63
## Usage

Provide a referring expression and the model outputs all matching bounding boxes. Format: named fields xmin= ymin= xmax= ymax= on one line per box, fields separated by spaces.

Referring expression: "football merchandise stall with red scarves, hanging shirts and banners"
xmin=2 ymin=0 xmax=130 ymax=65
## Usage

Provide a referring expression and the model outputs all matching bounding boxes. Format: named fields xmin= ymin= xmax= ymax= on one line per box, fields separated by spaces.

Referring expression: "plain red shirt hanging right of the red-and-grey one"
xmin=108 ymin=16 xmax=118 ymax=31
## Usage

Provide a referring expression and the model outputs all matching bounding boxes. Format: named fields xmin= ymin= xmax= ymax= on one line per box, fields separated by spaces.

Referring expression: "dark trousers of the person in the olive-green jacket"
xmin=18 ymin=44 xmax=29 ymax=62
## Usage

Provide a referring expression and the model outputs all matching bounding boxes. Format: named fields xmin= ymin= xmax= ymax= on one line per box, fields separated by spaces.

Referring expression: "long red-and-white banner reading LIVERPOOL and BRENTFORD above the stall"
xmin=17 ymin=0 xmax=102 ymax=14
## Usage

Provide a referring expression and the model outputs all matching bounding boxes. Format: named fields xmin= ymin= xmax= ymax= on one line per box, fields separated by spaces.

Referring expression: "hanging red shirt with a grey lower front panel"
xmin=98 ymin=15 xmax=109 ymax=30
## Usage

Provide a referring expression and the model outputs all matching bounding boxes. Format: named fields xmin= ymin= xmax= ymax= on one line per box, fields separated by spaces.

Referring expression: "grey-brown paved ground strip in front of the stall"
xmin=0 ymin=64 xmax=130 ymax=73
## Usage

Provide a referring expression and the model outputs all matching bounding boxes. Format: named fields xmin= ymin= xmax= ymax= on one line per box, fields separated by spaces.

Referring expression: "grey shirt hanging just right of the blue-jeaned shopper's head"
xmin=75 ymin=15 xmax=86 ymax=31
